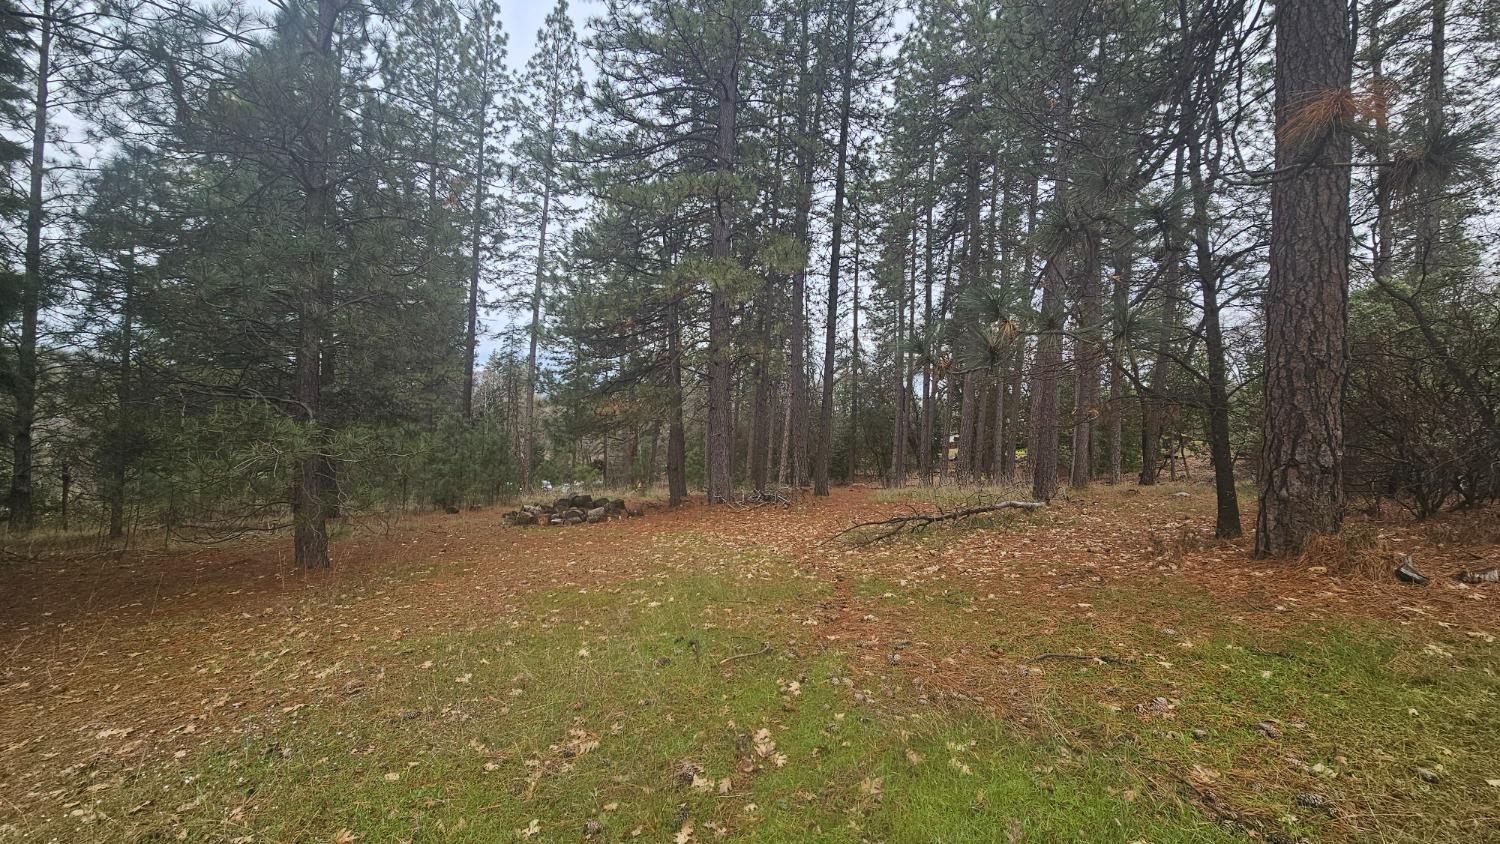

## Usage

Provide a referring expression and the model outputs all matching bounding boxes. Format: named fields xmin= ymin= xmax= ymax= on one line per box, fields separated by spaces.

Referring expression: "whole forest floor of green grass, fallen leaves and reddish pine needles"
xmin=0 ymin=484 xmax=1500 ymax=844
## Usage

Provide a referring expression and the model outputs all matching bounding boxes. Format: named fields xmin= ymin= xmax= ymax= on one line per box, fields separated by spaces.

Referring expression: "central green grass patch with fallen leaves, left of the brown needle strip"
xmin=36 ymin=539 xmax=1230 ymax=843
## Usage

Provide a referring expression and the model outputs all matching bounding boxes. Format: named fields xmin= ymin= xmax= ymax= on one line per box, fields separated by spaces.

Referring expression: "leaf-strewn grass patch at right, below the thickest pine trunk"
xmin=828 ymin=577 xmax=1500 ymax=843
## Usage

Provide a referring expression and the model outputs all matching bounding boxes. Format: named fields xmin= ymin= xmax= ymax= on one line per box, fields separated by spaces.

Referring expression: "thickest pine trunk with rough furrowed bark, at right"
xmin=1256 ymin=0 xmax=1352 ymax=556
